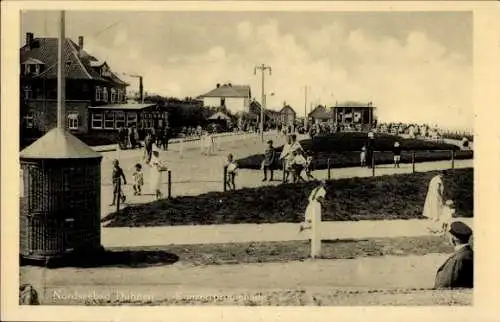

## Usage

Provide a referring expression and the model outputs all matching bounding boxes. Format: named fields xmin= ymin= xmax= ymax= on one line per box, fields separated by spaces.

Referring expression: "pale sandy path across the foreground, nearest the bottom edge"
xmin=21 ymin=254 xmax=454 ymax=300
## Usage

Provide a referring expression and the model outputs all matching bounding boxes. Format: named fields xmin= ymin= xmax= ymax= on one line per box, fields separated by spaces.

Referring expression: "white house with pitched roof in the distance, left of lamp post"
xmin=198 ymin=83 xmax=252 ymax=114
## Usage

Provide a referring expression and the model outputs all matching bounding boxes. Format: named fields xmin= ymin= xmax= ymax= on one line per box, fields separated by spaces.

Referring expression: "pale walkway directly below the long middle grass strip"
xmin=101 ymin=218 xmax=474 ymax=247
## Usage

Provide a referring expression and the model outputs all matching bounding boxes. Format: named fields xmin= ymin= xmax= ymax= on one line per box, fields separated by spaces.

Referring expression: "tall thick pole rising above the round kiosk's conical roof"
xmin=57 ymin=11 xmax=66 ymax=130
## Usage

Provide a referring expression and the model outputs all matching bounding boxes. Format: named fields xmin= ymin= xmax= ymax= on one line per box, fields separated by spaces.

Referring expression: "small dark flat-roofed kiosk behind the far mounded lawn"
xmin=333 ymin=102 xmax=376 ymax=130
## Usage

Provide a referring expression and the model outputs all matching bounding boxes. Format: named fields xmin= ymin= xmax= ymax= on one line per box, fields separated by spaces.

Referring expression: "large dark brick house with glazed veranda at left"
xmin=20 ymin=33 xmax=159 ymax=135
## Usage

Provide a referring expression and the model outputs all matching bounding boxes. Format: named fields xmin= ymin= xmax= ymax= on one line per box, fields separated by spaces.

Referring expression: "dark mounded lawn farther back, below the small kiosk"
xmin=237 ymin=132 xmax=473 ymax=170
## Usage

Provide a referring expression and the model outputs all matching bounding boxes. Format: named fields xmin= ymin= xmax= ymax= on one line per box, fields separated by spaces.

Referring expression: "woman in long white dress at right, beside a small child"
xmin=422 ymin=174 xmax=444 ymax=232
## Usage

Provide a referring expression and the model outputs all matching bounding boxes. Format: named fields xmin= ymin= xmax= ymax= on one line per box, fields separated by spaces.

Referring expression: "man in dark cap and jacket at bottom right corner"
xmin=434 ymin=221 xmax=474 ymax=288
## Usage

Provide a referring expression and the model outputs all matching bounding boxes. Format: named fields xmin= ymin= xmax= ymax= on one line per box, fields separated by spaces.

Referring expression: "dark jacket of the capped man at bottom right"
xmin=434 ymin=245 xmax=474 ymax=288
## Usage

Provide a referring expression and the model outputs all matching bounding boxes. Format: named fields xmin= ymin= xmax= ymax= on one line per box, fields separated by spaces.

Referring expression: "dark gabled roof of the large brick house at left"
xmin=20 ymin=38 xmax=128 ymax=86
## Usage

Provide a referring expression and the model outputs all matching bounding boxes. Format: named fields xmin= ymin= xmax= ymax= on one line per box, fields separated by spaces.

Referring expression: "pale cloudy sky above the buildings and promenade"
xmin=20 ymin=11 xmax=474 ymax=129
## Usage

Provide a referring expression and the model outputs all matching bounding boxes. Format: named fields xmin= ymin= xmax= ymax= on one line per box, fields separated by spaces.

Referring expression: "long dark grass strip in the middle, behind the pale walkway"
xmin=102 ymin=168 xmax=474 ymax=227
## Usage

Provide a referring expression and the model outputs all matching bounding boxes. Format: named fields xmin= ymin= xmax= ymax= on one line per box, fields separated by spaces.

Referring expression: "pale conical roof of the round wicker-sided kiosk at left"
xmin=20 ymin=127 xmax=102 ymax=159
